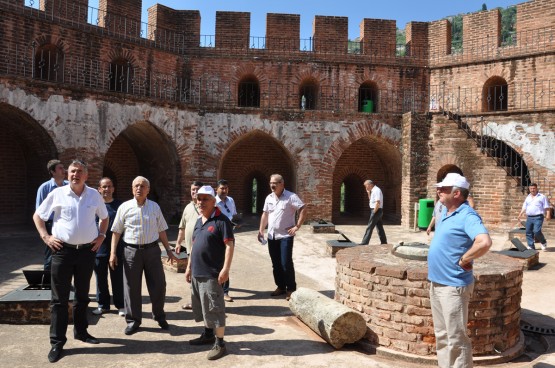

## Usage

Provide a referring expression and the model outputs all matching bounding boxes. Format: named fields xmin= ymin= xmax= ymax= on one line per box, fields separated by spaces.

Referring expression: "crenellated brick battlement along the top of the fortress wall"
xmin=6 ymin=0 xmax=555 ymax=66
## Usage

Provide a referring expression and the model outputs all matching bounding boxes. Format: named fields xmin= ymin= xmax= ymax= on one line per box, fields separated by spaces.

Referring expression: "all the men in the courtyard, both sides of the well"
xmin=33 ymin=160 xmax=551 ymax=367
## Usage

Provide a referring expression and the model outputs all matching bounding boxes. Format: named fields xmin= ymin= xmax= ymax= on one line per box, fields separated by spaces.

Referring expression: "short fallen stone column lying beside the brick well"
xmin=289 ymin=288 xmax=366 ymax=349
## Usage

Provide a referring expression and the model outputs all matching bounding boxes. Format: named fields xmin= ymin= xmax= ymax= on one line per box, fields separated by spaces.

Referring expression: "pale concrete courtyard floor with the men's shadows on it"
xmin=0 ymin=225 xmax=555 ymax=368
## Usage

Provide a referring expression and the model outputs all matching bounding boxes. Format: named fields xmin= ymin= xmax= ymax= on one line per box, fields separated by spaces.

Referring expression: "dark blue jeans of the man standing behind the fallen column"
xmin=268 ymin=236 xmax=297 ymax=291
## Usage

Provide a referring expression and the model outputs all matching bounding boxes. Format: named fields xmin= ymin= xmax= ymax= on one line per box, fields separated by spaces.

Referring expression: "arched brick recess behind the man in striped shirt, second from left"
xmin=102 ymin=121 xmax=181 ymax=220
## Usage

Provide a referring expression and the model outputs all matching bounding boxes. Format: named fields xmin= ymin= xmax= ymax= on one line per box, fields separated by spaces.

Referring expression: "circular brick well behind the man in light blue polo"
xmin=335 ymin=245 xmax=524 ymax=363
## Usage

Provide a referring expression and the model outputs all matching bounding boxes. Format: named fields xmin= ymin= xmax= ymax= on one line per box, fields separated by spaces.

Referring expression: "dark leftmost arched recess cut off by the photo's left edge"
xmin=0 ymin=102 xmax=58 ymax=225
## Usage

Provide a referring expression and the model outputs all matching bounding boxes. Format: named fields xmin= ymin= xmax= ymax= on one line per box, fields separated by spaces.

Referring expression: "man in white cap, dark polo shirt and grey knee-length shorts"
xmin=185 ymin=185 xmax=235 ymax=360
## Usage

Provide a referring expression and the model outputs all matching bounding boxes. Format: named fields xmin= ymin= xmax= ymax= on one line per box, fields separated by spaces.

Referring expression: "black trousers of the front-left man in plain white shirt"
xmin=50 ymin=246 xmax=96 ymax=347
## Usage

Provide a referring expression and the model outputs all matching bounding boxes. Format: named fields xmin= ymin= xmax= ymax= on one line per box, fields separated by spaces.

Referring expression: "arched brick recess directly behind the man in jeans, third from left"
xmin=218 ymin=130 xmax=296 ymax=214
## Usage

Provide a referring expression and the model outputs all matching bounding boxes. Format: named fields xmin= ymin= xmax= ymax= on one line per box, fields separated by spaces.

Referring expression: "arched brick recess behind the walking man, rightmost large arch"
xmin=332 ymin=135 xmax=401 ymax=224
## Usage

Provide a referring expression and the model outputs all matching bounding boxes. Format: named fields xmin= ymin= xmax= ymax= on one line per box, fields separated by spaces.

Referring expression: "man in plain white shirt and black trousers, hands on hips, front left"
xmin=33 ymin=160 xmax=108 ymax=363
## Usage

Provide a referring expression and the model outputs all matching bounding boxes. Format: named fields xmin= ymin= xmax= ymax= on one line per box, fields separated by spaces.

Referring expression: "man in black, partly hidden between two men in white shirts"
xmin=93 ymin=177 xmax=125 ymax=317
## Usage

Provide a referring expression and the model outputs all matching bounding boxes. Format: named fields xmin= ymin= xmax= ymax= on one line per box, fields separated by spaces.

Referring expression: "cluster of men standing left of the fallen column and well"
xmin=33 ymin=160 xmax=306 ymax=363
